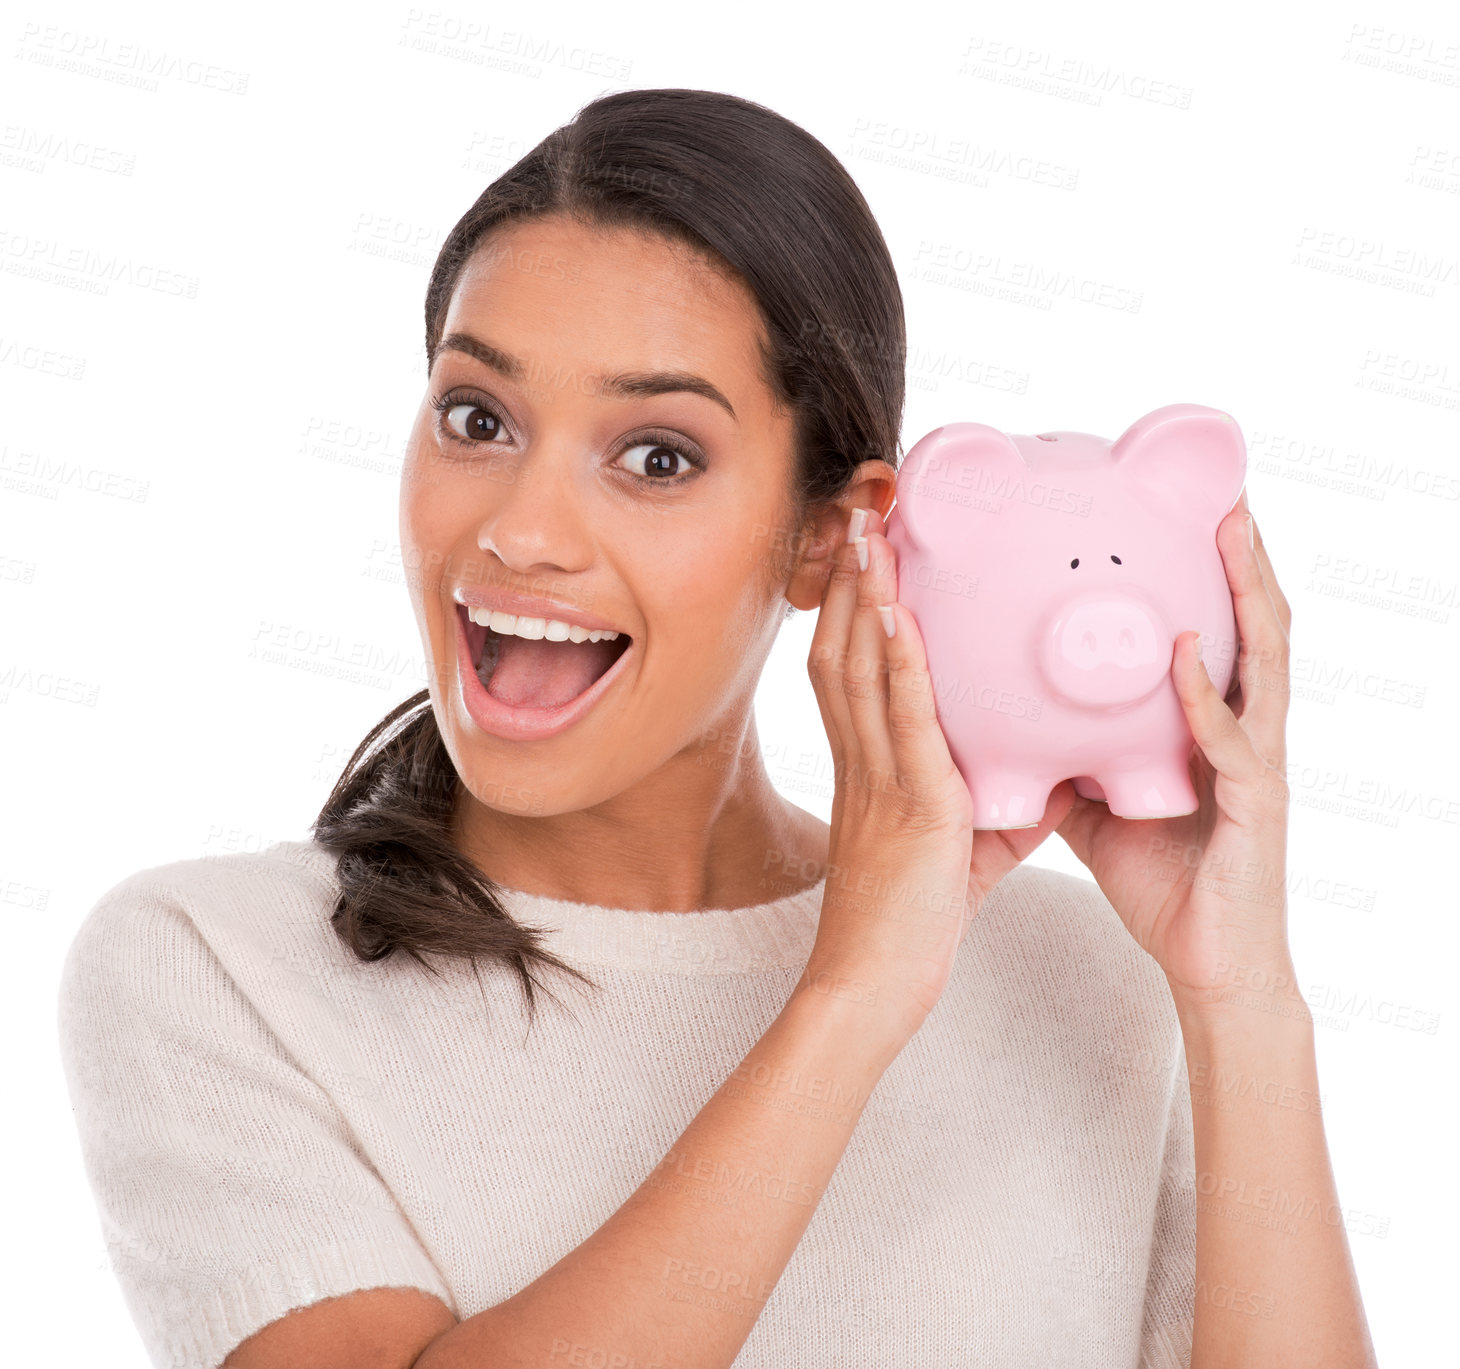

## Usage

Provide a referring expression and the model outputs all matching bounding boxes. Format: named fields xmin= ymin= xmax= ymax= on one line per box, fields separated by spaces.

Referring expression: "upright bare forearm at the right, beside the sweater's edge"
xmin=1177 ymin=966 xmax=1375 ymax=1369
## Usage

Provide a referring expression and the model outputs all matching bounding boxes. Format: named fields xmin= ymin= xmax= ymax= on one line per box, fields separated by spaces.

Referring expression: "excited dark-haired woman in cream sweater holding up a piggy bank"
xmin=61 ymin=90 xmax=1372 ymax=1369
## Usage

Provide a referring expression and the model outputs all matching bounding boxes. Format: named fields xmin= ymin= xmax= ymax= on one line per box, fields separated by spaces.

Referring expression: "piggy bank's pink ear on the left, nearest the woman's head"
xmin=896 ymin=423 xmax=1028 ymax=550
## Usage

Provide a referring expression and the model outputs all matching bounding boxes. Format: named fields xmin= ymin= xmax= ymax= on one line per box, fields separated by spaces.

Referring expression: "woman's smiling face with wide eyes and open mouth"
xmin=400 ymin=216 xmax=823 ymax=835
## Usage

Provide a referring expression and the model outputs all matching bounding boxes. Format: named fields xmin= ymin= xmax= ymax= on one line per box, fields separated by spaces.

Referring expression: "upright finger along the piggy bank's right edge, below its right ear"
xmin=1218 ymin=493 xmax=1291 ymax=768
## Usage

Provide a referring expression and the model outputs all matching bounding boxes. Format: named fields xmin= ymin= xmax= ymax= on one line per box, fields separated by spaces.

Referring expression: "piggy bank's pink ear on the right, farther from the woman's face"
xmin=1110 ymin=404 xmax=1247 ymax=527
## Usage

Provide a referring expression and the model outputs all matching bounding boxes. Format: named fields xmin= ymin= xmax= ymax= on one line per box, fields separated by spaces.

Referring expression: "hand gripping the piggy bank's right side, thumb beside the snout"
xmin=1056 ymin=489 xmax=1294 ymax=1011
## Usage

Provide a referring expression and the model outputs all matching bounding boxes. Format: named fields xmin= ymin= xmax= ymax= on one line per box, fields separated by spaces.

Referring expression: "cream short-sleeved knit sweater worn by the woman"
xmin=58 ymin=841 xmax=1196 ymax=1369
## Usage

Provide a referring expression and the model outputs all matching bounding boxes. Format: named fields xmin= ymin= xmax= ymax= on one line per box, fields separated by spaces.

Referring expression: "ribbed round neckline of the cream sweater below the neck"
xmin=279 ymin=839 xmax=826 ymax=975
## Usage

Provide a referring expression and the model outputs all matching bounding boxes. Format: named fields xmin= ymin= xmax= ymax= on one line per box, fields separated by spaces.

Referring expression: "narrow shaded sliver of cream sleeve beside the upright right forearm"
xmin=1140 ymin=1036 xmax=1196 ymax=1369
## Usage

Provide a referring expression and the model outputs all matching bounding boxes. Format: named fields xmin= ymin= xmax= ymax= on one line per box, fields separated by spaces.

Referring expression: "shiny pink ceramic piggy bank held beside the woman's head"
xmin=886 ymin=404 xmax=1247 ymax=828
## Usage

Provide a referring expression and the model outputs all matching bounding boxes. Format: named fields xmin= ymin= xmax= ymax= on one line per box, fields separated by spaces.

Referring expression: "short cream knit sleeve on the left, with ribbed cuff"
xmin=58 ymin=874 xmax=453 ymax=1369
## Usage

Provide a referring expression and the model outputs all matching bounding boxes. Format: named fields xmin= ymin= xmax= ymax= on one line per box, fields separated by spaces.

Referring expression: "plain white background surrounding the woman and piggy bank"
xmin=0 ymin=0 xmax=1460 ymax=1369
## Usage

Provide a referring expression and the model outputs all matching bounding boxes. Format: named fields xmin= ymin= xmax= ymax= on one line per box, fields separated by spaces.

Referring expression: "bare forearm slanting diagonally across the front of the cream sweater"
xmin=415 ymin=981 xmax=901 ymax=1369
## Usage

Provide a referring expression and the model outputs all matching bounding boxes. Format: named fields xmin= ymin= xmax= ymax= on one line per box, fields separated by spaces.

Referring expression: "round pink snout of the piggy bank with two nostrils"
xmin=1038 ymin=590 xmax=1175 ymax=708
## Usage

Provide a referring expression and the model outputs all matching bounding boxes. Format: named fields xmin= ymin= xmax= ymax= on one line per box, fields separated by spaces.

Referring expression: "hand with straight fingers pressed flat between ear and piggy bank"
xmin=803 ymin=509 xmax=1075 ymax=1039
